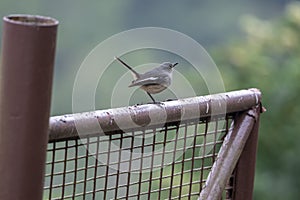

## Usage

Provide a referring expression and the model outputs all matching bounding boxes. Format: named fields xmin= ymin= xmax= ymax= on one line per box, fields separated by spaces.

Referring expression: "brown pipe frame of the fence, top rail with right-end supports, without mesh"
xmin=45 ymin=89 xmax=262 ymax=200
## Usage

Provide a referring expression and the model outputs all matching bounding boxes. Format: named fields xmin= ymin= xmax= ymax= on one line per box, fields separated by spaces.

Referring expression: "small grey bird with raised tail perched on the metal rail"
xmin=115 ymin=57 xmax=178 ymax=104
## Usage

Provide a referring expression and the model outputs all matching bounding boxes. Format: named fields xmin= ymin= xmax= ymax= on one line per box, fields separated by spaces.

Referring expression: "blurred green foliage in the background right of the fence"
xmin=213 ymin=2 xmax=300 ymax=199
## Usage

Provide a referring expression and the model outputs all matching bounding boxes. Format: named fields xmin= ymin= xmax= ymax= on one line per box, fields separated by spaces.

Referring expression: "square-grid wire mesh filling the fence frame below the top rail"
xmin=44 ymin=116 xmax=234 ymax=200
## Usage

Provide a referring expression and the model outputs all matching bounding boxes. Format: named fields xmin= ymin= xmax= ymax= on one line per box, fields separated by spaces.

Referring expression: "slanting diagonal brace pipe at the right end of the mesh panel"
xmin=199 ymin=107 xmax=260 ymax=200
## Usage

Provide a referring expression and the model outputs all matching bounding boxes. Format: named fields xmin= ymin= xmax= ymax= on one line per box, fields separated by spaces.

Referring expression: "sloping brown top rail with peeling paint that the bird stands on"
xmin=49 ymin=89 xmax=261 ymax=142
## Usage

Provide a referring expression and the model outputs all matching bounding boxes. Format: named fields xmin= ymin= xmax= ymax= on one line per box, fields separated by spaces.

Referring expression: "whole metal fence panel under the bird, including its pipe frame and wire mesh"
xmin=44 ymin=89 xmax=260 ymax=199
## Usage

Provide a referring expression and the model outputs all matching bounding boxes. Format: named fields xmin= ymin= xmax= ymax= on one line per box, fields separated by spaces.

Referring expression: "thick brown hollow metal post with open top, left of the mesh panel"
xmin=0 ymin=15 xmax=58 ymax=200
